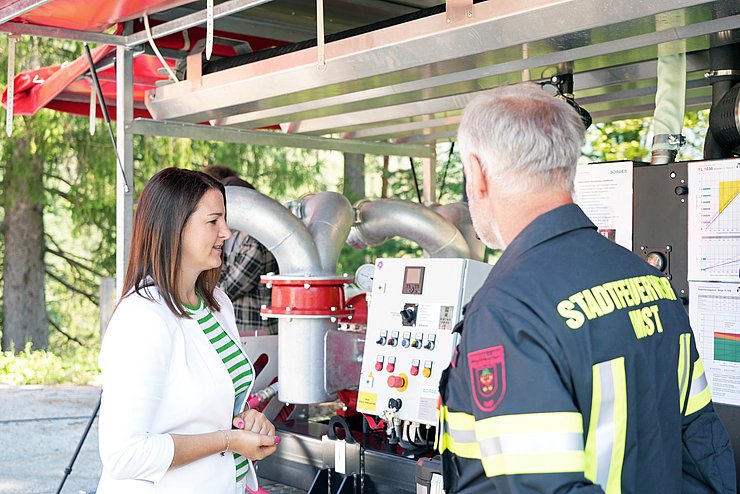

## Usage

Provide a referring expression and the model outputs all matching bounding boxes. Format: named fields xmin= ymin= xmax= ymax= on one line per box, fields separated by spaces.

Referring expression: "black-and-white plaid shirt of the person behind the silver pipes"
xmin=219 ymin=231 xmax=278 ymax=334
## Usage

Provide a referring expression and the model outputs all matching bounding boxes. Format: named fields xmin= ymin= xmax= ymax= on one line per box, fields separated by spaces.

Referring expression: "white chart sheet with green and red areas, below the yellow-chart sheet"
xmin=689 ymin=282 xmax=740 ymax=405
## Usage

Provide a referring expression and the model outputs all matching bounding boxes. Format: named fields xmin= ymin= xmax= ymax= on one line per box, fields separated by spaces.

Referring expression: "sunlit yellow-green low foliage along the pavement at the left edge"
xmin=0 ymin=343 xmax=98 ymax=385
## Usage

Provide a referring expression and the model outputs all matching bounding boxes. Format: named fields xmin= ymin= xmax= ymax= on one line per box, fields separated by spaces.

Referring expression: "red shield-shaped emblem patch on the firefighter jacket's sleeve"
xmin=468 ymin=345 xmax=506 ymax=412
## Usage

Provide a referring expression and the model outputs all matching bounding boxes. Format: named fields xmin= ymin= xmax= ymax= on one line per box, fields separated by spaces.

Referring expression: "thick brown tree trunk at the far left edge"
xmin=2 ymin=117 xmax=49 ymax=352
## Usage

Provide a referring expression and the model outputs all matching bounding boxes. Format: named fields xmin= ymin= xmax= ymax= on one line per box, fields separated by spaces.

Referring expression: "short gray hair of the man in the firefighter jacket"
xmin=457 ymin=83 xmax=584 ymax=193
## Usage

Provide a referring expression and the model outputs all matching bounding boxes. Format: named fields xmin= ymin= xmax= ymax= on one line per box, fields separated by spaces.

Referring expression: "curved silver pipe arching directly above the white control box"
xmin=347 ymin=199 xmax=470 ymax=258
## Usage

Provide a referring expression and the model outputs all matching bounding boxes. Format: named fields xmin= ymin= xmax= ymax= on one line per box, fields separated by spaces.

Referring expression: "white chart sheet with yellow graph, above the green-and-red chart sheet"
xmin=688 ymin=159 xmax=740 ymax=282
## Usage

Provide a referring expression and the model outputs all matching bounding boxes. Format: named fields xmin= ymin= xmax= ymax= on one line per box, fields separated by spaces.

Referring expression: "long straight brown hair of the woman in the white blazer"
xmin=122 ymin=168 xmax=226 ymax=317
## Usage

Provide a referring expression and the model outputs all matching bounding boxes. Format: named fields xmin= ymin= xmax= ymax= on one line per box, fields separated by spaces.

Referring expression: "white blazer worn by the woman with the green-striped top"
xmin=97 ymin=287 xmax=257 ymax=494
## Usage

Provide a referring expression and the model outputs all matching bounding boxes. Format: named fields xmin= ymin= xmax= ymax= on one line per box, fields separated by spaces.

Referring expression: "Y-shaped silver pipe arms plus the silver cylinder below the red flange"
xmin=226 ymin=186 xmax=353 ymax=403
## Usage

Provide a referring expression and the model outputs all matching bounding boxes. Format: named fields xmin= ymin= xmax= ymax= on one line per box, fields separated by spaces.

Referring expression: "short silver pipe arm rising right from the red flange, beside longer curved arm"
xmin=299 ymin=192 xmax=354 ymax=275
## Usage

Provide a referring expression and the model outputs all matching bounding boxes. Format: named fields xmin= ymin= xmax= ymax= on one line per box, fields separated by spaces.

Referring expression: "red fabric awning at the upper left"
xmin=0 ymin=0 xmax=286 ymax=119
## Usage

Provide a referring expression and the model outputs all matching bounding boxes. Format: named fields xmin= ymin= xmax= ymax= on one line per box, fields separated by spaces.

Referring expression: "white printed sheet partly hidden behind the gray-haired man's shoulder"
xmin=574 ymin=161 xmax=633 ymax=250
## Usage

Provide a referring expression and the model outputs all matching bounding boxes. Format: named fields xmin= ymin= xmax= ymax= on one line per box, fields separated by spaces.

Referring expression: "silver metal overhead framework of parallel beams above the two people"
xmin=5 ymin=0 xmax=740 ymax=151
